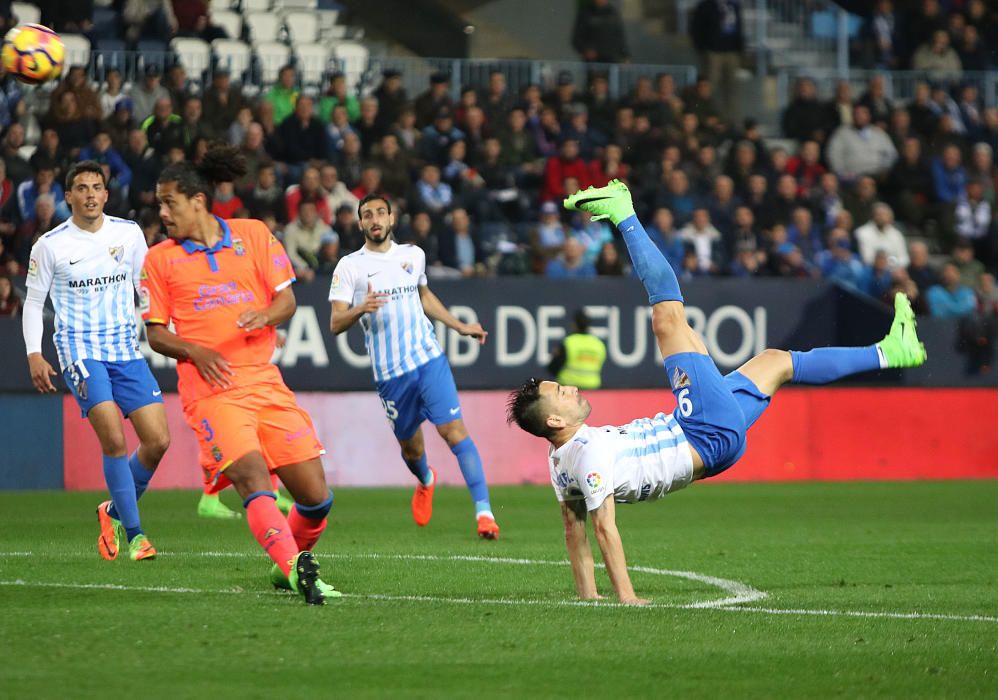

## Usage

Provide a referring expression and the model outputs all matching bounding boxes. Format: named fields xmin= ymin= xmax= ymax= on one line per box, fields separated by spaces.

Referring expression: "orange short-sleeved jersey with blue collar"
xmin=140 ymin=217 xmax=295 ymax=404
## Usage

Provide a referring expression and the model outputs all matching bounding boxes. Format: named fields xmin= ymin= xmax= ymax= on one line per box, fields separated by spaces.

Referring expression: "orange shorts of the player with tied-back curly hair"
xmin=184 ymin=384 xmax=325 ymax=493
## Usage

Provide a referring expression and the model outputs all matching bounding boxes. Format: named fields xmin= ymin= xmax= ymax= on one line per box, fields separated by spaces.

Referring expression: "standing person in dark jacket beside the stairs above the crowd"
xmin=690 ymin=0 xmax=745 ymax=119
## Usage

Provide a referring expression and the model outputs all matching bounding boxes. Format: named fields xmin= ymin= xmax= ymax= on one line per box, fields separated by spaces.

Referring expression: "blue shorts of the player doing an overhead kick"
xmin=665 ymin=352 xmax=770 ymax=477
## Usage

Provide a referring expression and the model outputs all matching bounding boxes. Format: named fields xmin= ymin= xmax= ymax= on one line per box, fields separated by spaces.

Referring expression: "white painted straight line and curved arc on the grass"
xmin=0 ymin=552 xmax=998 ymax=623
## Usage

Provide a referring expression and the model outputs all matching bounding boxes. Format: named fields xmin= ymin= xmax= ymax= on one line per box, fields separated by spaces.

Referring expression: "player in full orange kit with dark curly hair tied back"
xmin=140 ymin=147 xmax=339 ymax=605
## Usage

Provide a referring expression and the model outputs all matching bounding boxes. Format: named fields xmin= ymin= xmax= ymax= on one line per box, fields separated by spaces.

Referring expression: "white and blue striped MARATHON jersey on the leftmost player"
xmin=28 ymin=215 xmax=147 ymax=371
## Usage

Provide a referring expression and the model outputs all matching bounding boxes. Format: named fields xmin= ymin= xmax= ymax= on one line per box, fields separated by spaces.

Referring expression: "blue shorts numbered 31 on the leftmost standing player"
xmin=62 ymin=360 xmax=163 ymax=418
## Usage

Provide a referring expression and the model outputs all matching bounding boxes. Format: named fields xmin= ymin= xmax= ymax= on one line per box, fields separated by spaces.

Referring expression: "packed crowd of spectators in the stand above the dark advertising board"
xmin=0 ymin=0 xmax=998 ymax=334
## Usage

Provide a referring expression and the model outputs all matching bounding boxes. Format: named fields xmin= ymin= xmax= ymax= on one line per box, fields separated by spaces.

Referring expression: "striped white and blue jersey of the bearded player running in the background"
xmin=329 ymin=242 xmax=443 ymax=382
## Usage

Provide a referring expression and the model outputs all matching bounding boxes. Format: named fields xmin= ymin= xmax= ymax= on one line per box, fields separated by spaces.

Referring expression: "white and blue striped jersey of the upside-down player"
xmin=548 ymin=413 xmax=693 ymax=510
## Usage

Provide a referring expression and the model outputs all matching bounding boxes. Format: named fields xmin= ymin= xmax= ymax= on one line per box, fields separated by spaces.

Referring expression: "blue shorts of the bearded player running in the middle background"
xmin=378 ymin=355 xmax=461 ymax=440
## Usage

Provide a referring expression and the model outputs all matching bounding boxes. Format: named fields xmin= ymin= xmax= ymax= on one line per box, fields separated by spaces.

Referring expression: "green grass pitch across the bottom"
xmin=0 ymin=481 xmax=998 ymax=698
